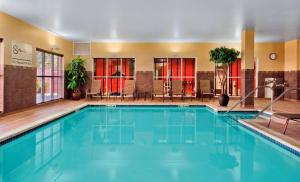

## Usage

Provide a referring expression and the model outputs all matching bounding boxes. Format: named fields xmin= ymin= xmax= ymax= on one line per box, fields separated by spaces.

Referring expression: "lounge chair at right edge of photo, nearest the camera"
xmin=268 ymin=113 xmax=300 ymax=134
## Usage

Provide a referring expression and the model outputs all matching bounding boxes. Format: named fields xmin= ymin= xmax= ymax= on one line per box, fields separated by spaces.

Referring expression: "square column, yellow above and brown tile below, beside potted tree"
xmin=241 ymin=29 xmax=254 ymax=107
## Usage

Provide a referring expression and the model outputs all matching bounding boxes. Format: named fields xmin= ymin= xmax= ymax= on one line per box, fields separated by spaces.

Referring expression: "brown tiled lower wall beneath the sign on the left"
xmin=4 ymin=65 xmax=36 ymax=112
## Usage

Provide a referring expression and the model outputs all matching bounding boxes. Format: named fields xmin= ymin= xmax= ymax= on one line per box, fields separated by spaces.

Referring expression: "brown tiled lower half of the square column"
xmin=241 ymin=69 xmax=254 ymax=106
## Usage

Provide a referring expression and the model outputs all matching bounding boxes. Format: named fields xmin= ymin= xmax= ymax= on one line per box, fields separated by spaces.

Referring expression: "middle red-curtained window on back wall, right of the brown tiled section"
xmin=154 ymin=58 xmax=196 ymax=96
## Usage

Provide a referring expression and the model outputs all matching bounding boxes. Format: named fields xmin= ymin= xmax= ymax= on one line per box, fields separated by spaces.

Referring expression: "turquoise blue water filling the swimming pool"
xmin=0 ymin=106 xmax=300 ymax=182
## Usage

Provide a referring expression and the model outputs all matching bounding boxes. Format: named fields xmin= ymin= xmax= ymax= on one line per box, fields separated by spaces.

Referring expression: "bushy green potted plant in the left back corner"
xmin=66 ymin=56 xmax=88 ymax=100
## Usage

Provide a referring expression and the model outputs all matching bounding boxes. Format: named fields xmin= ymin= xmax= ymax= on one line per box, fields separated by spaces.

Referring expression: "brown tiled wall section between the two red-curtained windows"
xmin=135 ymin=71 xmax=153 ymax=93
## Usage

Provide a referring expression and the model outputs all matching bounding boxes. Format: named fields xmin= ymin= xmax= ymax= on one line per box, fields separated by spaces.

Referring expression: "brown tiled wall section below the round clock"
xmin=257 ymin=71 xmax=284 ymax=98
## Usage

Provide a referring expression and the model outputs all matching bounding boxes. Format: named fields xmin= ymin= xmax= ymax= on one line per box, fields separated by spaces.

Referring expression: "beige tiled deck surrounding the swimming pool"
xmin=0 ymin=99 xmax=300 ymax=149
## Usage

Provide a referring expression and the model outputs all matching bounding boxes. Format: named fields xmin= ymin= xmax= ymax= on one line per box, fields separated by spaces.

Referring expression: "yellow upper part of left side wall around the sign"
xmin=0 ymin=12 xmax=73 ymax=66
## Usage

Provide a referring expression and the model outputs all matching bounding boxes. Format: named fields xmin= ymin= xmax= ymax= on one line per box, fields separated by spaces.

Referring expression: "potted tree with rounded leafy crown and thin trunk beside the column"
xmin=209 ymin=46 xmax=240 ymax=106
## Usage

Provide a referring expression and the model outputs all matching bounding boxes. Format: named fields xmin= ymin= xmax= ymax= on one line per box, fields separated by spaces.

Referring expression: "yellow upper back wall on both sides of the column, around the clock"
xmin=87 ymin=43 xmax=284 ymax=71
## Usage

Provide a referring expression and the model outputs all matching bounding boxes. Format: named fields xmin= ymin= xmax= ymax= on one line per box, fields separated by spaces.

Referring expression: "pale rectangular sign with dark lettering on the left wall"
xmin=11 ymin=40 xmax=32 ymax=67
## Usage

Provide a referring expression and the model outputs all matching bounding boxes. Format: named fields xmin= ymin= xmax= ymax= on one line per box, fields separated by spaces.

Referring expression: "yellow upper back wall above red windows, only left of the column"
xmin=88 ymin=43 xmax=239 ymax=71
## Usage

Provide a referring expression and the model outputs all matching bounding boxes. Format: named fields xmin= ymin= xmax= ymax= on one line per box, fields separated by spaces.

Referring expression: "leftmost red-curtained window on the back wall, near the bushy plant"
xmin=94 ymin=58 xmax=135 ymax=96
